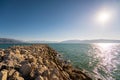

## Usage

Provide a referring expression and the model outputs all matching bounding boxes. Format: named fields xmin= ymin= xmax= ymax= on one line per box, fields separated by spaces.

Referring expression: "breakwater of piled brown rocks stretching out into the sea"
xmin=0 ymin=45 xmax=92 ymax=80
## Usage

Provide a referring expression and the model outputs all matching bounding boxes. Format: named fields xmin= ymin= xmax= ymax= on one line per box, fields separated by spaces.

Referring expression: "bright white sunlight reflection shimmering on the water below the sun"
xmin=92 ymin=43 xmax=119 ymax=80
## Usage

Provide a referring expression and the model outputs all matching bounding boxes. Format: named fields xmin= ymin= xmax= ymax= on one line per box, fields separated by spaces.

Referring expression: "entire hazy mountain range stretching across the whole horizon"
xmin=0 ymin=38 xmax=120 ymax=44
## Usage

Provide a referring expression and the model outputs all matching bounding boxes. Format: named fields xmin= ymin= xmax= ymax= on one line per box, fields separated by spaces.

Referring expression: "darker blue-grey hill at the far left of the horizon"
xmin=0 ymin=38 xmax=24 ymax=44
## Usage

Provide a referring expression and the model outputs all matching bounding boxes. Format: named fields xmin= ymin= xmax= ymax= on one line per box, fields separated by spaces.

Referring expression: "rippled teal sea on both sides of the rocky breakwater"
xmin=0 ymin=43 xmax=120 ymax=80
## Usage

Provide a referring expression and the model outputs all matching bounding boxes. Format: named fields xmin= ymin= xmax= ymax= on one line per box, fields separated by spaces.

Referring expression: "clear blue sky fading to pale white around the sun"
xmin=0 ymin=0 xmax=120 ymax=41
